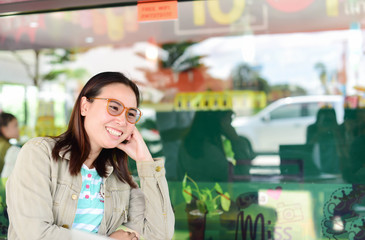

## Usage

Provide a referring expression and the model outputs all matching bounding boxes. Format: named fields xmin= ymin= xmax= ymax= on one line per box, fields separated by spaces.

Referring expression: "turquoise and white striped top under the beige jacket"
xmin=72 ymin=164 xmax=104 ymax=233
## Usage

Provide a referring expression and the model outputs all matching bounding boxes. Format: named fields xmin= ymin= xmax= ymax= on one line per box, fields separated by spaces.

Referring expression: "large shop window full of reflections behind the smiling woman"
xmin=0 ymin=0 xmax=365 ymax=240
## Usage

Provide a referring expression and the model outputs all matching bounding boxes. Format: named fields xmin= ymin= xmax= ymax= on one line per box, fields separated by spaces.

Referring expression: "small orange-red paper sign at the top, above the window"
xmin=137 ymin=0 xmax=178 ymax=22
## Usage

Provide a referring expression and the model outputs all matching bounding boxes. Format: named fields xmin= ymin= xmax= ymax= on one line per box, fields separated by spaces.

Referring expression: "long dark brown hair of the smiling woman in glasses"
xmin=52 ymin=72 xmax=140 ymax=188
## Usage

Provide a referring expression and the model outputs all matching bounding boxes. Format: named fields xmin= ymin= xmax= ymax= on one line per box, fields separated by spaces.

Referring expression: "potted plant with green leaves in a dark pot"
xmin=182 ymin=174 xmax=231 ymax=240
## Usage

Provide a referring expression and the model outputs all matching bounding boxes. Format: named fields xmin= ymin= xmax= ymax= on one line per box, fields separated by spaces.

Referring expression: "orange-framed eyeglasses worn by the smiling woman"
xmin=88 ymin=98 xmax=142 ymax=124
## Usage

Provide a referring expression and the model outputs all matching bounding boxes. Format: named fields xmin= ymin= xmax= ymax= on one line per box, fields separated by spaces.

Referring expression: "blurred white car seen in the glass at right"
xmin=232 ymin=95 xmax=344 ymax=153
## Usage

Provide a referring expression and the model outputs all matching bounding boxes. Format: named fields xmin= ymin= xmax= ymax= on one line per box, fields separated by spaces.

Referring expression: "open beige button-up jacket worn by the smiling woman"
xmin=6 ymin=138 xmax=175 ymax=240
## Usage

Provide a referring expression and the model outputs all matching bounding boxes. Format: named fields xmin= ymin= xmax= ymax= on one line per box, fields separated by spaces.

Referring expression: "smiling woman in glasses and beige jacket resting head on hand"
xmin=6 ymin=72 xmax=174 ymax=240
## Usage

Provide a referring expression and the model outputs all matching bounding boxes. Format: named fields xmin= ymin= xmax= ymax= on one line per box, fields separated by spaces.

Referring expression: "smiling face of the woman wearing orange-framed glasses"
xmin=81 ymin=83 xmax=137 ymax=152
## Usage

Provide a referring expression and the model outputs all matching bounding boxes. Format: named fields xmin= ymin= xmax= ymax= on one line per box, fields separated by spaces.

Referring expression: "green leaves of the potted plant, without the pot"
xmin=182 ymin=174 xmax=231 ymax=214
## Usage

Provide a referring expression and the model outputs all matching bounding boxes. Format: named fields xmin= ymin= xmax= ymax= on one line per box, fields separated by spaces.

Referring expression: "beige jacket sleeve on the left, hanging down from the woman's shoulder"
xmin=6 ymin=138 xmax=71 ymax=240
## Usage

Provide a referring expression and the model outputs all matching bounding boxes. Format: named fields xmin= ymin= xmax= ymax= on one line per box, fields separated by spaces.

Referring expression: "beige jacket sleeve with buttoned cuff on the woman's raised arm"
xmin=125 ymin=159 xmax=175 ymax=240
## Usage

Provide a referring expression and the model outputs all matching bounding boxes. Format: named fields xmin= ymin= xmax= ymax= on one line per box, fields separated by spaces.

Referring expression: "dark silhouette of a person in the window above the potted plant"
xmin=177 ymin=110 xmax=254 ymax=182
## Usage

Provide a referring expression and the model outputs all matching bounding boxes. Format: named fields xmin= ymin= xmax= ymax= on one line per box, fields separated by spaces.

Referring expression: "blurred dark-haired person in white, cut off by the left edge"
xmin=0 ymin=112 xmax=20 ymax=178
